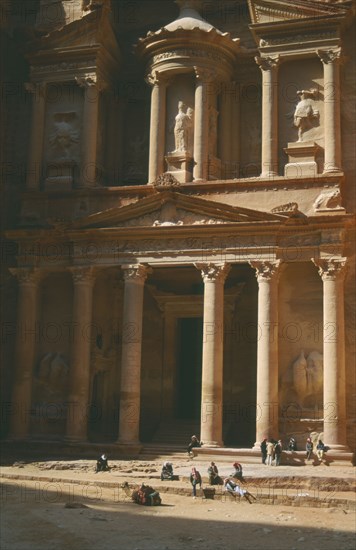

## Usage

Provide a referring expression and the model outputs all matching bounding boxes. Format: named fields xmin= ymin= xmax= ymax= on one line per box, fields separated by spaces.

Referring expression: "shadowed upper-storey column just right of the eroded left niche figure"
xmin=76 ymin=75 xmax=101 ymax=187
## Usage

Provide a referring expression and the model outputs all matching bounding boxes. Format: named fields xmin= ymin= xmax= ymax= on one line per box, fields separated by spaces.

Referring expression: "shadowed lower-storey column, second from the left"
xmin=66 ymin=267 xmax=94 ymax=441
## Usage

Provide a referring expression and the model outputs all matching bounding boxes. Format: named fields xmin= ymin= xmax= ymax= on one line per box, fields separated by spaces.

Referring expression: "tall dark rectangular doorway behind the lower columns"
xmin=176 ymin=317 xmax=203 ymax=420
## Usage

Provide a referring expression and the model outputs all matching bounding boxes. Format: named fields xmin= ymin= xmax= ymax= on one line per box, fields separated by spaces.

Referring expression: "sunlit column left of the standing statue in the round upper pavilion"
xmin=147 ymin=71 xmax=167 ymax=183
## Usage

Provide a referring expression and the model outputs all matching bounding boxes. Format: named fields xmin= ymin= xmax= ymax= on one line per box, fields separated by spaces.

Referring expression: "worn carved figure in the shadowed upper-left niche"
xmin=49 ymin=112 xmax=79 ymax=160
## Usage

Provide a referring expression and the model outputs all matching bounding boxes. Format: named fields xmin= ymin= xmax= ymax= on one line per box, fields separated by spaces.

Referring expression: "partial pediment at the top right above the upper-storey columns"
xmin=249 ymin=0 xmax=347 ymax=24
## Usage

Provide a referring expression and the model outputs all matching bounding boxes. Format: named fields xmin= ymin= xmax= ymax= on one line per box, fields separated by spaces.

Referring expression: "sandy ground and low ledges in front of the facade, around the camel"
xmin=0 ymin=462 xmax=356 ymax=550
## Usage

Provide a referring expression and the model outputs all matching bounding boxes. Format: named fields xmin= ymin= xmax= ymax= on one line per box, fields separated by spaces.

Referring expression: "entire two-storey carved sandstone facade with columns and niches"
xmin=2 ymin=0 xmax=356 ymax=456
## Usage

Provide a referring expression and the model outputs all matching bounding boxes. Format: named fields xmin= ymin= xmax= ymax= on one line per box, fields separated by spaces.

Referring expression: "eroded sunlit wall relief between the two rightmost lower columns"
xmin=282 ymin=350 xmax=323 ymax=409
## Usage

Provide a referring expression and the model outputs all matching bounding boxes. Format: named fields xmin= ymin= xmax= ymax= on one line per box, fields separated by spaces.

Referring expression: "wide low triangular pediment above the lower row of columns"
xmin=66 ymin=191 xmax=285 ymax=230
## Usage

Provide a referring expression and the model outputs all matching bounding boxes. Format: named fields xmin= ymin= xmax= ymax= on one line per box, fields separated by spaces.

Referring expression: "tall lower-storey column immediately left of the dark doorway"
xmin=118 ymin=264 xmax=149 ymax=444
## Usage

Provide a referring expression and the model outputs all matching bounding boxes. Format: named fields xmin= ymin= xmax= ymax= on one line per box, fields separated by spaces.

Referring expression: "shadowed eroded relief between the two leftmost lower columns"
xmin=36 ymin=352 xmax=69 ymax=403
